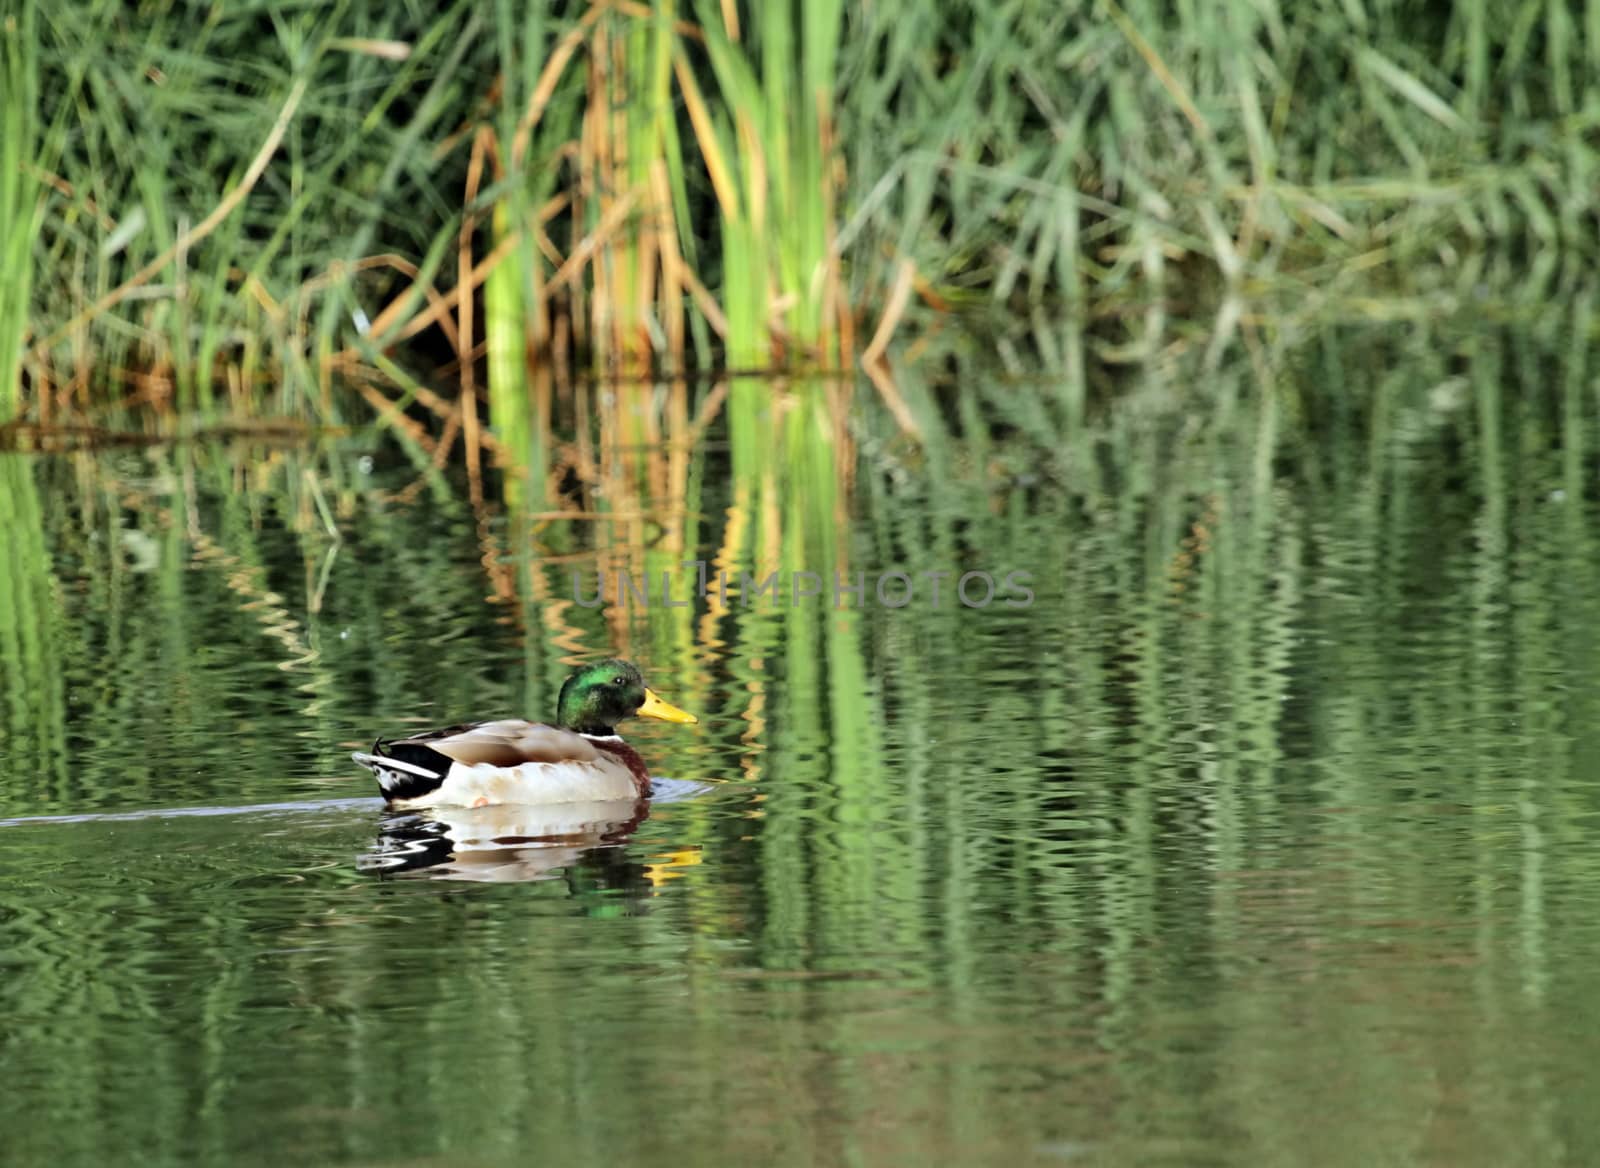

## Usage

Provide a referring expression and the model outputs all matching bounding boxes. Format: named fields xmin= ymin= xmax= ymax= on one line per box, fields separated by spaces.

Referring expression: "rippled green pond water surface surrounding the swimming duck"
xmin=0 ymin=313 xmax=1600 ymax=1165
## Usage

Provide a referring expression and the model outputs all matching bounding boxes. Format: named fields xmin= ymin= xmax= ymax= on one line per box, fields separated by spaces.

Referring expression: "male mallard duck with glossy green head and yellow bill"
xmin=350 ymin=659 xmax=699 ymax=808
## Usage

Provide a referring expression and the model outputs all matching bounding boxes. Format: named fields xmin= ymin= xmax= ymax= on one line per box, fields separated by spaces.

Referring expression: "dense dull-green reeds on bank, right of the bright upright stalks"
xmin=840 ymin=0 xmax=1600 ymax=320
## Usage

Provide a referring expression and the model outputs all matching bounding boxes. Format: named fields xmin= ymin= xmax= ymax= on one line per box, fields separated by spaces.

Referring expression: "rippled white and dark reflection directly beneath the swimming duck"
xmin=357 ymin=798 xmax=650 ymax=891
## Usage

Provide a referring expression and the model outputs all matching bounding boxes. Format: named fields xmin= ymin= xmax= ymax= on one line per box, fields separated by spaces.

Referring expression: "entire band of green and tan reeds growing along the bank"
xmin=0 ymin=0 xmax=1600 ymax=483
